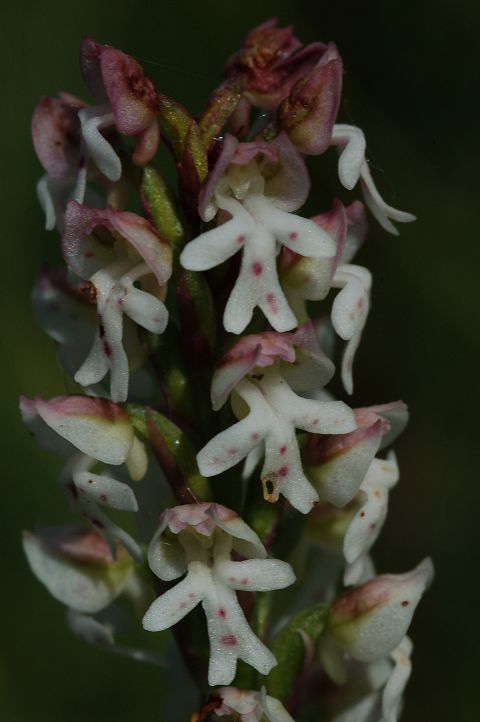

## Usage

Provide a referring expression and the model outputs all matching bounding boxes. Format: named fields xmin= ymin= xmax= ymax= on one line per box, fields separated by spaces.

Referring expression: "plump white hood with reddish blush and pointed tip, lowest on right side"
xmin=329 ymin=558 xmax=433 ymax=662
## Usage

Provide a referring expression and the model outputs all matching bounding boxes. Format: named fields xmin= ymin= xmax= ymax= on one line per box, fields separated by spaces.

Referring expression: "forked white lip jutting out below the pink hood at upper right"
xmin=331 ymin=125 xmax=415 ymax=236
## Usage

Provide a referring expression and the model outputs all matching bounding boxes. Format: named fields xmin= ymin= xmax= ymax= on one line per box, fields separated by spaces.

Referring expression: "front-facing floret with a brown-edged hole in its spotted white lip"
xmin=197 ymin=326 xmax=356 ymax=514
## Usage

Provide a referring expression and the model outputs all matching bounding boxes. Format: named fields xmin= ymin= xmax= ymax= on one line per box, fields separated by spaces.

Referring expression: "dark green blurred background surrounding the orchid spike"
xmin=0 ymin=0 xmax=480 ymax=722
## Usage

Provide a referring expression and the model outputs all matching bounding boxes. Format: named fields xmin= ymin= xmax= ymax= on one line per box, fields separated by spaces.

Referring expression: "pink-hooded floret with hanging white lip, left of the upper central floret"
xmin=62 ymin=201 xmax=172 ymax=401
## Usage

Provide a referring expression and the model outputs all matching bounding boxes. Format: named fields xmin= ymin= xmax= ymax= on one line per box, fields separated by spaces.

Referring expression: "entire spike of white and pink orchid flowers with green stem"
xmin=20 ymin=21 xmax=433 ymax=722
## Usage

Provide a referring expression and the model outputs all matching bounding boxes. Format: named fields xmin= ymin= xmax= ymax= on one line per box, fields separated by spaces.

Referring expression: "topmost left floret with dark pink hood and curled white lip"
xmin=78 ymin=38 xmax=160 ymax=181
